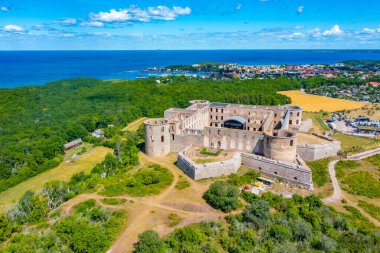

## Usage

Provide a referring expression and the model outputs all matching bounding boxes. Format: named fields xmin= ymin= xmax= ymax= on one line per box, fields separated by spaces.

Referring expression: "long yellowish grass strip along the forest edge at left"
xmin=0 ymin=147 xmax=112 ymax=213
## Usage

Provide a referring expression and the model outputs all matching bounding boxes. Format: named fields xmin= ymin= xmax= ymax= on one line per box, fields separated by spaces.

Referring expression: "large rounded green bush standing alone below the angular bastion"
xmin=203 ymin=181 xmax=239 ymax=212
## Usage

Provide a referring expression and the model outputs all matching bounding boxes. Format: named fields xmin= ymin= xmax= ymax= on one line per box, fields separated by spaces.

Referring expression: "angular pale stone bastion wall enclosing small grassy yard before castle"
xmin=177 ymin=148 xmax=241 ymax=180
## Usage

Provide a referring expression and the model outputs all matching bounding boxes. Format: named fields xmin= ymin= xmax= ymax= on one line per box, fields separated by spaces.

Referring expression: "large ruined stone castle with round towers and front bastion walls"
xmin=145 ymin=100 xmax=312 ymax=188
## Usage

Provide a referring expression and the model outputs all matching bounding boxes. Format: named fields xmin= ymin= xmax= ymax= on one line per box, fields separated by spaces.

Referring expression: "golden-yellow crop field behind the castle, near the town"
xmin=279 ymin=90 xmax=366 ymax=112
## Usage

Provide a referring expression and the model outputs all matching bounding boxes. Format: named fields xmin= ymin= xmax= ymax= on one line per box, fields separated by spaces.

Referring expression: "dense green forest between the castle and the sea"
xmin=0 ymin=77 xmax=374 ymax=192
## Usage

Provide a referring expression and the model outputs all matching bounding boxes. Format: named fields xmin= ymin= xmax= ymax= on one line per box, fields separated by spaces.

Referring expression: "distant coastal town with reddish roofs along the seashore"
xmin=144 ymin=61 xmax=380 ymax=80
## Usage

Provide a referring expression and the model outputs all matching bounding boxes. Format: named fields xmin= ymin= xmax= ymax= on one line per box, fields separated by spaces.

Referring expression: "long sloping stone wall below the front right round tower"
xmin=241 ymin=153 xmax=313 ymax=189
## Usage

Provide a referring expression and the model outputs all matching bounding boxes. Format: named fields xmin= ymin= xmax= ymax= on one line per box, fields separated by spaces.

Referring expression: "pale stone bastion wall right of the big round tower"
xmin=297 ymin=133 xmax=340 ymax=161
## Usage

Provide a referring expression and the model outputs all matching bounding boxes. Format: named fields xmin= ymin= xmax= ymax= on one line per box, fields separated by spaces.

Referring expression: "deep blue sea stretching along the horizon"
xmin=0 ymin=50 xmax=380 ymax=88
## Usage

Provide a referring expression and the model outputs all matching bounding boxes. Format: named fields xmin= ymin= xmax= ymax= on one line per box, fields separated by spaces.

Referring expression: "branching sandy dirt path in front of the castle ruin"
xmin=57 ymin=153 xmax=226 ymax=253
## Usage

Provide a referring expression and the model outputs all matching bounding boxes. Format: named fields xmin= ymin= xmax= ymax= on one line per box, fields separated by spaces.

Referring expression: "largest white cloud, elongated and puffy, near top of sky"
xmin=90 ymin=6 xmax=191 ymax=23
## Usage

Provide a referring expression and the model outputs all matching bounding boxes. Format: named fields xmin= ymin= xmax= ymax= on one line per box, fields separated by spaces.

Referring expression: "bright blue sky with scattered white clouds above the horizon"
xmin=0 ymin=0 xmax=380 ymax=50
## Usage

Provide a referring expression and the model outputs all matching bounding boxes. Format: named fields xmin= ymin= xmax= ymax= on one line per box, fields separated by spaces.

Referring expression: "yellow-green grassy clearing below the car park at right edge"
xmin=332 ymin=133 xmax=380 ymax=154
